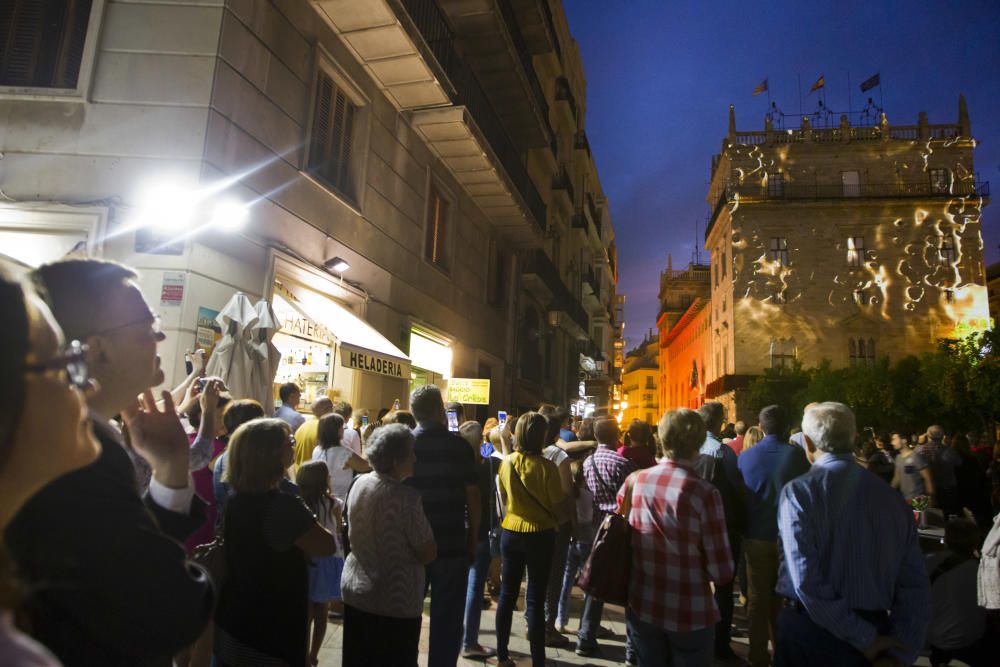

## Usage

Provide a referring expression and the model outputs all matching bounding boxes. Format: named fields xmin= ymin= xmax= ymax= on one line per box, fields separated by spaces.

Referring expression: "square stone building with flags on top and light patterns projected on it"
xmin=705 ymin=97 xmax=989 ymax=419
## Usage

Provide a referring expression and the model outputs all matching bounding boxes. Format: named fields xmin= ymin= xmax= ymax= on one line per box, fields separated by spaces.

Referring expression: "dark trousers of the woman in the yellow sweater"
xmin=497 ymin=528 xmax=556 ymax=667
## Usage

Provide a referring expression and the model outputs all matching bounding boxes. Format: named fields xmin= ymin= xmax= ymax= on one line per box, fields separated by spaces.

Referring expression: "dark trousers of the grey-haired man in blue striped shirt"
xmin=772 ymin=605 xmax=889 ymax=667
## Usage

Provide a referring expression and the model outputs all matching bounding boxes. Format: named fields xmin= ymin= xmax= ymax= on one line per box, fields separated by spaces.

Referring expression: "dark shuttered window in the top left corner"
xmin=0 ymin=0 xmax=92 ymax=88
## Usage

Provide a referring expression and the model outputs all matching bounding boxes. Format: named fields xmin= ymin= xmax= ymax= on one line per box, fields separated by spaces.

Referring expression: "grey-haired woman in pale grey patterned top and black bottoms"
xmin=341 ymin=424 xmax=437 ymax=667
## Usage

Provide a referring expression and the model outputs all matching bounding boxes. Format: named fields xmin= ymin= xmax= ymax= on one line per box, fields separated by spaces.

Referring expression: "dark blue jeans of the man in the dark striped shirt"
xmin=427 ymin=556 xmax=469 ymax=667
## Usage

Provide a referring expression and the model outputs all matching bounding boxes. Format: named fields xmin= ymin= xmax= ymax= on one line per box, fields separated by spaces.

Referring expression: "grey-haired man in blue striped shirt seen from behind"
xmin=774 ymin=403 xmax=930 ymax=667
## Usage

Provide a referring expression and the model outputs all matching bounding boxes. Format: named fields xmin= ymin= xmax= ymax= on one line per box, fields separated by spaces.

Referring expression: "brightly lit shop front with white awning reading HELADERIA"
xmin=271 ymin=275 xmax=411 ymax=412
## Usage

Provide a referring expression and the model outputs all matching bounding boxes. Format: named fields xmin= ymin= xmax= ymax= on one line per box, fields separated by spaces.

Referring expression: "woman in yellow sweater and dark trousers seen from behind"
xmin=497 ymin=412 xmax=564 ymax=667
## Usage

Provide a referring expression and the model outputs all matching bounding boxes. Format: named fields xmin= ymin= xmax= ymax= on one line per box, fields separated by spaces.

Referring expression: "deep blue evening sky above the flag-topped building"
xmin=564 ymin=0 xmax=1000 ymax=346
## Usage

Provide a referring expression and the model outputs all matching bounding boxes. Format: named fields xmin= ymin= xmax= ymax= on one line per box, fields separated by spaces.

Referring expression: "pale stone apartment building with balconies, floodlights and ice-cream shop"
xmin=0 ymin=0 xmax=615 ymax=412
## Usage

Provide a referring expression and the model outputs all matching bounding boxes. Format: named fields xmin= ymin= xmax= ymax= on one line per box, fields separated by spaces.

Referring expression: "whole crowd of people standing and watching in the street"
xmin=0 ymin=259 xmax=1000 ymax=667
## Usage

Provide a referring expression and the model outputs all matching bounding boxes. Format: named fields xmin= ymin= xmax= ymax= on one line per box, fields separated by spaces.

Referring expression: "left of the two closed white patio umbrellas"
xmin=205 ymin=292 xmax=257 ymax=398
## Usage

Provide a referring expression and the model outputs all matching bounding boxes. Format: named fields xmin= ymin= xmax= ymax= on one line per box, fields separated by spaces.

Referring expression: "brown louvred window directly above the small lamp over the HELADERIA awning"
xmin=309 ymin=69 xmax=357 ymax=201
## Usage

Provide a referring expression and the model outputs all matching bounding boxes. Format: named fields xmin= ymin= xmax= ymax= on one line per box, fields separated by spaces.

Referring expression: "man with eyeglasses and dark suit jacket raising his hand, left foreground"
xmin=4 ymin=259 xmax=213 ymax=665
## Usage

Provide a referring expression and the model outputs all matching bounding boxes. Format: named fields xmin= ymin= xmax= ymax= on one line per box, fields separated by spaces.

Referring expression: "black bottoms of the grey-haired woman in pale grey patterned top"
xmin=343 ymin=604 xmax=420 ymax=667
